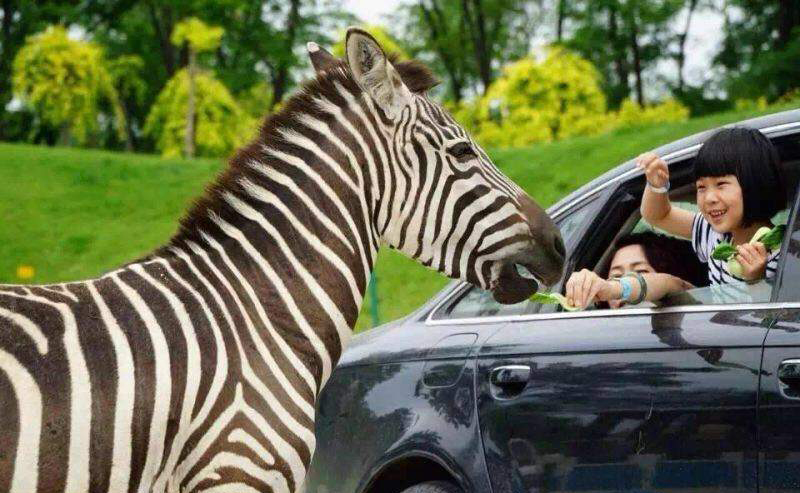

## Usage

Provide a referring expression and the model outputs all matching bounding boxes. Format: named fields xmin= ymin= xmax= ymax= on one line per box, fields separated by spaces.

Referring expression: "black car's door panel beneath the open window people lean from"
xmin=476 ymin=182 xmax=780 ymax=492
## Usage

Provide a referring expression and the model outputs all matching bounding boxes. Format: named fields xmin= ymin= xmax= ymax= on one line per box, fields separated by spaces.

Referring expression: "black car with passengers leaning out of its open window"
xmin=306 ymin=110 xmax=800 ymax=493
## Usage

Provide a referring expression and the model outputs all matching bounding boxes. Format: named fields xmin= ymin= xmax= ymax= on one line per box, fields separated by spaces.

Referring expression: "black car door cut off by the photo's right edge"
xmin=758 ymin=179 xmax=800 ymax=493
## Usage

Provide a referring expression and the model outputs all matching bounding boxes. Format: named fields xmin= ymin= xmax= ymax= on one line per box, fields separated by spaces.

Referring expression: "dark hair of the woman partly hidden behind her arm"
xmin=603 ymin=231 xmax=709 ymax=287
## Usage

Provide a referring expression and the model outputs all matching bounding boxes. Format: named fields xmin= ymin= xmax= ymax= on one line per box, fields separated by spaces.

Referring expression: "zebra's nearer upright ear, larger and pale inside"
xmin=345 ymin=27 xmax=411 ymax=119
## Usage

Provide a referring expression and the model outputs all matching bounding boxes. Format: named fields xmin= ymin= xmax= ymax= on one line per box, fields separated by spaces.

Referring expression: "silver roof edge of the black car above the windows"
xmin=547 ymin=109 xmax=800 ymax=214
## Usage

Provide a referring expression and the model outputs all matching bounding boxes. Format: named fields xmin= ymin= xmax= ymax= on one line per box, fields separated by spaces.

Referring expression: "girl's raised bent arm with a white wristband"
xmin=636 ymin=152 xmax=694 ymax=238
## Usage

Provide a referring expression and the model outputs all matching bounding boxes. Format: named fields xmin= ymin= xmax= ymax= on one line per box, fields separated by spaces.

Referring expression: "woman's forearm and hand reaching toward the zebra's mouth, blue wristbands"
xmin=564 ymin=269 xmax=693 ymax=308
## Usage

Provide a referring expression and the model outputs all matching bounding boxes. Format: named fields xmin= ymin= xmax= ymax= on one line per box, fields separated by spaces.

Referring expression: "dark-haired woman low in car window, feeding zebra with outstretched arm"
xmin=564 ymin=232 xmax=708 ymax=308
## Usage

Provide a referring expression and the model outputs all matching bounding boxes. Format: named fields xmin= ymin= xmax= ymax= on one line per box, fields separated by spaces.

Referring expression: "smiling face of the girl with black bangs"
xmin=695 ymin=175 xmax=744 ymax=233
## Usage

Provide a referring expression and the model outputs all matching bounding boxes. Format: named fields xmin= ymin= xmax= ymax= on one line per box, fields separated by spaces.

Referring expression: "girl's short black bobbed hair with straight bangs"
xmin=694 ymin=127 xmax=786 ymax=226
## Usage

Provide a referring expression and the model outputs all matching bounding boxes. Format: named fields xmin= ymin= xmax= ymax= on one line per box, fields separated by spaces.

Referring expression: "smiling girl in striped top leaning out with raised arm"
xmin=637 ymin=127 xmax=786 ymax=286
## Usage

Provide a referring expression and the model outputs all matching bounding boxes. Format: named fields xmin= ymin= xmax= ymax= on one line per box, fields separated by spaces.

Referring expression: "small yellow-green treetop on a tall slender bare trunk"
xmin=172 ymin=17 xmax=224 ymax=157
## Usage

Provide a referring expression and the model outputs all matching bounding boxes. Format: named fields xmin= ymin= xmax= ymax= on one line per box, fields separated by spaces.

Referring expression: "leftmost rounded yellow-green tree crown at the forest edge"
xmin=12 ymin=26 xmax=125 ymax=144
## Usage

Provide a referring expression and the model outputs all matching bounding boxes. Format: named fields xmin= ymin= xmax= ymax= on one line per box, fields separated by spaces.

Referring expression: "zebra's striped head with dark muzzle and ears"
xmin=308 ymin=28 xmax=565 ymax=303
